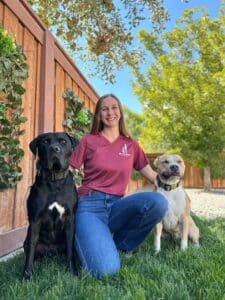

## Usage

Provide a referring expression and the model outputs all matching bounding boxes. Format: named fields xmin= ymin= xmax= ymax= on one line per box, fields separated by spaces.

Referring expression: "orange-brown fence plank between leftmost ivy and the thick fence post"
xmin=14 ymin=29 xmax=38 ymax=228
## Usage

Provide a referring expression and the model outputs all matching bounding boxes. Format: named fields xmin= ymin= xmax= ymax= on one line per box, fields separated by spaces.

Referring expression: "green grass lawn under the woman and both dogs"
xmin=0 ymin=217 xmax=225 ymax=300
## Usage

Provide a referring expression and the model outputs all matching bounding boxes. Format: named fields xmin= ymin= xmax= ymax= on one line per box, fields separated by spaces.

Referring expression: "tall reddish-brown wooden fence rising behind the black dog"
xmin=0 ymin=0 xmax=98 ymax=256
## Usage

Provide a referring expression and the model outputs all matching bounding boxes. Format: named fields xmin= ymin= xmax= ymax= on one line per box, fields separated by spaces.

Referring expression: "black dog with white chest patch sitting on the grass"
xmin=23 ymin=132 xmax=78 ymax=279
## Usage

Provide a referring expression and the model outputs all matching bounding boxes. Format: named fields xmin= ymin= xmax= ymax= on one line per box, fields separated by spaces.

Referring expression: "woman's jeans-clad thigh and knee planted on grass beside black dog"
xmin=75 ymin=212 xmax=120 ymax=277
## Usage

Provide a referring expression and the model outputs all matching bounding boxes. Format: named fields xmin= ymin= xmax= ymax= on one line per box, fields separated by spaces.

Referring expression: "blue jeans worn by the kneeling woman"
xmin=75 ymin=191 xmax=167 ymax=277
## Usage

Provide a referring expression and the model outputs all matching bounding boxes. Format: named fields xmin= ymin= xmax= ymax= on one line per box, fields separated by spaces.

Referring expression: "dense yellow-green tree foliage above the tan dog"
xmin=134 ymin=4 xmax=225 ymax=177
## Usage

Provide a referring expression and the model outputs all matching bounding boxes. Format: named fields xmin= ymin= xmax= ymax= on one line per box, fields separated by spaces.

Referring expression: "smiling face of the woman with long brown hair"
xmin=100 ymin=96 xmax=121 ymax=127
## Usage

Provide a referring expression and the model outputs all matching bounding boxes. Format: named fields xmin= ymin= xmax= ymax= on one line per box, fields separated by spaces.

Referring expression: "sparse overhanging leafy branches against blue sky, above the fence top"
xmin=29 ymin=0 xmax=169 ymax=82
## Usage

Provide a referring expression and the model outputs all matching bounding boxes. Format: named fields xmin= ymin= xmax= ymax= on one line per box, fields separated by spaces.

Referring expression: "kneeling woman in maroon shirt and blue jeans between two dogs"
xmin=70 ymin=94 xmax=167 ymax=277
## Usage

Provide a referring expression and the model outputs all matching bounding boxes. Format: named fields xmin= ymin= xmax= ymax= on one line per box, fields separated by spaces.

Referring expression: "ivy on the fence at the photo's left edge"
xmin=0 ymin=27 xmax=28 ymax=191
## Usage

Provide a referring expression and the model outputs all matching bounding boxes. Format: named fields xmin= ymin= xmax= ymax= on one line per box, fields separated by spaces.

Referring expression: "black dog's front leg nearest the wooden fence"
xmin=23 ymin=222 xmax=41 ymax=280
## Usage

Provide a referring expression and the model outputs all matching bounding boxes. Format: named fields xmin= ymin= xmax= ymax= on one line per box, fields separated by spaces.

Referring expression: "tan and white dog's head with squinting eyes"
xmin=154 ymin=154 xmax=185 ymax=184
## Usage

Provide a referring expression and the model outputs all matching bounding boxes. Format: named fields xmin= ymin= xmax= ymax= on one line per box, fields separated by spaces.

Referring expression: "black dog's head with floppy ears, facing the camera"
xmin=29 ymin=132 xmax=78 ymax=172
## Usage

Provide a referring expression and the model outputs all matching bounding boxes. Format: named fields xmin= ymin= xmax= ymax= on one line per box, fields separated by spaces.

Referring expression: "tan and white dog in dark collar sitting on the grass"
xmin=154 ymin=155 xmax=199 ymax=253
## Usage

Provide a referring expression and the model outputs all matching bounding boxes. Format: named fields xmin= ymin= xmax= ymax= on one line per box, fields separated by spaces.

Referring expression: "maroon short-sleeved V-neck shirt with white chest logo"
xmin=70 ymin=134 xmax=148 ymax=196
